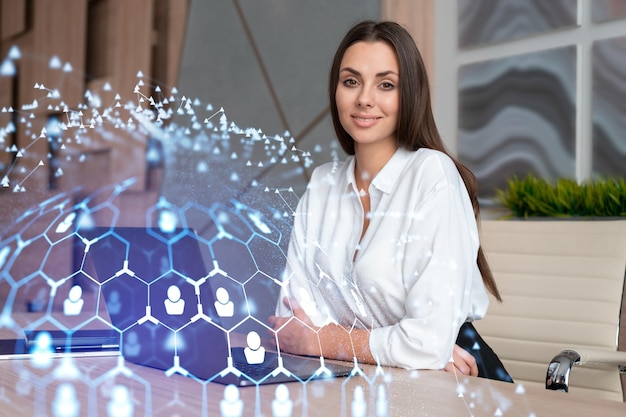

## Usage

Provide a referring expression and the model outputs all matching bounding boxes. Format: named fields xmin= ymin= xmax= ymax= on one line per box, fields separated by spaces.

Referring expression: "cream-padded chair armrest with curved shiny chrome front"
xmin=546 ymin=348 xmax=626 ymax=392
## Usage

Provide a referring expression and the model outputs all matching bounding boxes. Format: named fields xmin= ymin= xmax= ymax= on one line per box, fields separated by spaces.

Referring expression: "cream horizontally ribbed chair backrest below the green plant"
xmin=475 ymin=220 xmax=626 ymax=401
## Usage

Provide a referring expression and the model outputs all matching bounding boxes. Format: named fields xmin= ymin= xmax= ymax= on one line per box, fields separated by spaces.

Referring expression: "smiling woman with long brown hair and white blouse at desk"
xmin=269 ymin=21 xmax=506 ymax=375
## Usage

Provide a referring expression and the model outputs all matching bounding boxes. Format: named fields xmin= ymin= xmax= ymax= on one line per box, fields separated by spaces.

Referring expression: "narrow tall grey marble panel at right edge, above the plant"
xmin=592 ymin=36 xmax=626 ymax=177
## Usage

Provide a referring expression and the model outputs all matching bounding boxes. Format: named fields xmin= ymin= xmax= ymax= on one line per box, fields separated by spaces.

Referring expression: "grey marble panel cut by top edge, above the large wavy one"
xmin=458 ymin=0 xmax=578 ymax=48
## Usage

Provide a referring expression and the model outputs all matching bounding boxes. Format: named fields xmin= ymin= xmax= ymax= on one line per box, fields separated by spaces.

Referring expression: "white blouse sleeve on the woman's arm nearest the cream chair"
xmin=369 ymin=161 xmax=488 ymax=369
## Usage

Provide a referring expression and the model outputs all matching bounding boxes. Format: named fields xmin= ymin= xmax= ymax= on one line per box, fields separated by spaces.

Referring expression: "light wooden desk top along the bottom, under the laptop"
xmin=0 ymin=357 xmax=626 ymax=417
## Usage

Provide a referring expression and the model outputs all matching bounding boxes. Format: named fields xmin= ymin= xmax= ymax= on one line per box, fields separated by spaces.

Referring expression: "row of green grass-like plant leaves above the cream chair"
xmin=496 ymin=174 xmax=626 ymax=217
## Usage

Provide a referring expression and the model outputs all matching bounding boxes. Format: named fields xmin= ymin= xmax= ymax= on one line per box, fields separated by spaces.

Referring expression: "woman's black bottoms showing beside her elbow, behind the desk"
xmin=456 ymin=322 xmax=513 ymax=382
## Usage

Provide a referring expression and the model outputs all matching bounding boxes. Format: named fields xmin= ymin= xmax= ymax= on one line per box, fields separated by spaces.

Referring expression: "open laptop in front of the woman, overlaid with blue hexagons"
xmin=80 ymin=214 xmax=356 ymax=386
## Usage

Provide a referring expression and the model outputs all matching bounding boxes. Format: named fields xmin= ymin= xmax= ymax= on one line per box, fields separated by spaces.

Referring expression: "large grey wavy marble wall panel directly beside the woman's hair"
xmin=458 ymin=46 xmax=576 ymax=198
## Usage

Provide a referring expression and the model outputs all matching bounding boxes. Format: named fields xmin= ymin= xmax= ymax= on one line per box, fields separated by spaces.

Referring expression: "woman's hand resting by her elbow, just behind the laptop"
xmin=268 ymin=297 xmax=321 ymax=356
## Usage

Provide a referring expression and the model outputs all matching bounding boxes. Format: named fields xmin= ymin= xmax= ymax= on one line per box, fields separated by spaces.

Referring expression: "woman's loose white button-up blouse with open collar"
xmin=276 ymin=149 xmax=489 ymax=369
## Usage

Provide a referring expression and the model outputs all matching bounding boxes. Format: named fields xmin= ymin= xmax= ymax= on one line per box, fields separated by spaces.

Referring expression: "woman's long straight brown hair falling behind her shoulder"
xmin=328 ymin=20 xmax=502 ymax=301
